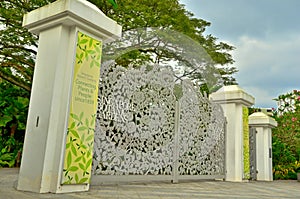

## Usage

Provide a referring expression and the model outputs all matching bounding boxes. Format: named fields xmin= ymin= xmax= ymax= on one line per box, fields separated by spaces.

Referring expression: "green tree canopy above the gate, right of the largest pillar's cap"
xmin=91 ymin=0 xmax=237 ymax=88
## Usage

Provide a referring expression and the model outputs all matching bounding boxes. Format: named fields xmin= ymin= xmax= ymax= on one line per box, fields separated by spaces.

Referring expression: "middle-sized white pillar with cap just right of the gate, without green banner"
xmin=210 ymin=85 xmax=254 ymax=182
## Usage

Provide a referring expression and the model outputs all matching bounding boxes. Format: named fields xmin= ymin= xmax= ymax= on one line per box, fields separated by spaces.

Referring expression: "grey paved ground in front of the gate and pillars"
xmin=0 ymin=169 xmax=300 ymax=199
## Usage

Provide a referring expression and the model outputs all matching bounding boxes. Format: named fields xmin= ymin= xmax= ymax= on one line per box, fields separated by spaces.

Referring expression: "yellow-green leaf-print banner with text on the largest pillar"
xmin=62 ymin=32 xmax=102 ymax=184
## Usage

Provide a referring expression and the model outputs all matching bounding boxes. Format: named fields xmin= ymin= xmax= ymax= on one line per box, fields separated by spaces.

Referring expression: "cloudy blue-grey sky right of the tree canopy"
xmin=180 ymin=0 xmax=300 ymax=108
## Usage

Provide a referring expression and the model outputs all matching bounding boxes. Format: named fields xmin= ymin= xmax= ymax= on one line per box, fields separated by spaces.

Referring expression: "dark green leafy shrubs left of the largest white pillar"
xmin=0 ymin=81 xmax=29 ymax=167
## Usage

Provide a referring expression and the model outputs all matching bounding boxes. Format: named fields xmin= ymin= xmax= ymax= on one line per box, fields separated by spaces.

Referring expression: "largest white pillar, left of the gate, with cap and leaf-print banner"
xmin=17 ymin=0 xmax=121 ymax=193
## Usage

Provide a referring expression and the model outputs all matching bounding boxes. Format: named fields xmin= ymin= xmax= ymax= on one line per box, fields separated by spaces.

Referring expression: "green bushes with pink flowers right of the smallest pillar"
xmin=272 ymin=90 xmax=300 ymax=179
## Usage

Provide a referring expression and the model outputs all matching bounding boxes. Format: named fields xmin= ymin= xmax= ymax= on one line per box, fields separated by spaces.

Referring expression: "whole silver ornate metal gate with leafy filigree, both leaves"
xmin=93 ymin=63 xmax=225 ymax=182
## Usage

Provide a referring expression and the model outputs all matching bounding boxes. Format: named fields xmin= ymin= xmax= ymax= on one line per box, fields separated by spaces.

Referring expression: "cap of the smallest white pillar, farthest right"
xmin=249 ymin=112 xmax=277 ymax=128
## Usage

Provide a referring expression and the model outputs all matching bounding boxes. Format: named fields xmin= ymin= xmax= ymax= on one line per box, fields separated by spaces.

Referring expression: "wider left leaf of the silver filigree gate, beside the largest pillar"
xmin=93 ymin=63 xmax=175 ymax=175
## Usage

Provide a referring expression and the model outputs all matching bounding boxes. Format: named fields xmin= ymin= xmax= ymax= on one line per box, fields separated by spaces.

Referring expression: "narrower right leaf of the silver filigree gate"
xmin=178 ymin=81 xmax=225 ymax=178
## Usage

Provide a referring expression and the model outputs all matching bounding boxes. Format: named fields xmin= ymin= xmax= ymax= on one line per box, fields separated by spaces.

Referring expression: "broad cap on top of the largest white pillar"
xmin=23 ymin=0 xmax=122 ymax=40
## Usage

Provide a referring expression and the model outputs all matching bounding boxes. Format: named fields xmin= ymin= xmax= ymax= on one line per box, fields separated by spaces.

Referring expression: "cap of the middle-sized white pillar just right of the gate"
xmin=210 ymin=85 xmax=255 ymax=106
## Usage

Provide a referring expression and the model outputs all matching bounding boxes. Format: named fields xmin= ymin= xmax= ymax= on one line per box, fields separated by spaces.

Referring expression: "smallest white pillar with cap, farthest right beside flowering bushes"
xmin=249 ymin=112 xmax=277 ymax=181
